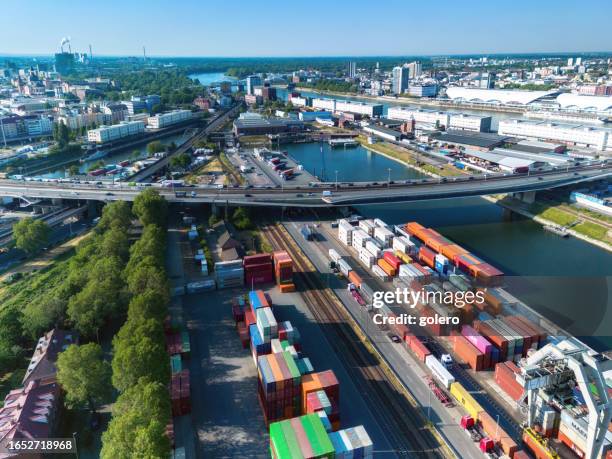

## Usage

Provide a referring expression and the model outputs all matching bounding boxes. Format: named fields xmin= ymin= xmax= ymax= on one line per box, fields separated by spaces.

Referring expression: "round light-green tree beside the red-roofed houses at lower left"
xmin=57 ymin=343 xmax=111 ymax=412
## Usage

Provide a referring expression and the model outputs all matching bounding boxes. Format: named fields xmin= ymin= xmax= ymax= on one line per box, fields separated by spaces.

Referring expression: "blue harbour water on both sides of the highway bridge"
xmin=284 ymin=143 xmax=612 ymax=350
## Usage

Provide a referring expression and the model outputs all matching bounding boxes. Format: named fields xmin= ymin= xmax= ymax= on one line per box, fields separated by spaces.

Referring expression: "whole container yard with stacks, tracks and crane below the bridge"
xmin=160 ymin=203 xmax=612 ymax=459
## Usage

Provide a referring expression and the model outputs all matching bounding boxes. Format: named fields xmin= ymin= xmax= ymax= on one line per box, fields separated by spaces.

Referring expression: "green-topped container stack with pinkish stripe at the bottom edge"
xmin=270 ymin=414 xmax=335 ymax=459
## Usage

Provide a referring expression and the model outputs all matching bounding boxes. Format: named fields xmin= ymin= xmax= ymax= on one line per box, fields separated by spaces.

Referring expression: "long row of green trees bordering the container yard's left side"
xmin=101 ymin=189 xmax=171 ymax=459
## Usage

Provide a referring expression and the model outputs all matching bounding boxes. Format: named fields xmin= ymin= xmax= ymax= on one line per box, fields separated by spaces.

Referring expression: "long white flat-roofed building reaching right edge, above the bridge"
xmin=498 ymin=119 xmax=612 ymax=150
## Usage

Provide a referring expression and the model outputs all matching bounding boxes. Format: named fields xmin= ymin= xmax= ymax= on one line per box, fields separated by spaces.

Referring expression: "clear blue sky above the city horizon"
xmin=0 ymin=0 xmax=612 ymax=56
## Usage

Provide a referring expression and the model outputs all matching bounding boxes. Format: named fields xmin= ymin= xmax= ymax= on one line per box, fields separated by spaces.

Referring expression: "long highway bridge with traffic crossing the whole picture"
xmin=0 ymin=163 xmax=612 ymax=207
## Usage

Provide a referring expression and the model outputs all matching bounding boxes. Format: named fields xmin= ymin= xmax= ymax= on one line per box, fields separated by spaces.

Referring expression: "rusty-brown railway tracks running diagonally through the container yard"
xmin=264 ymin=225 xmax=454 ymax=458
